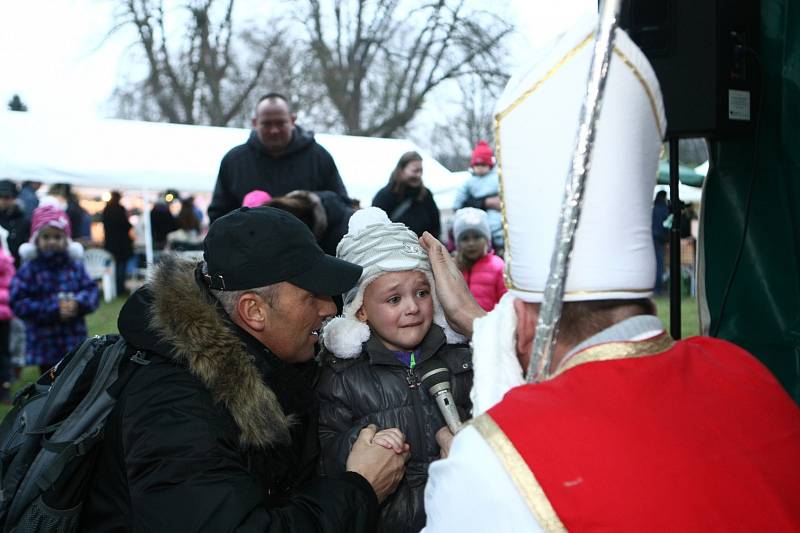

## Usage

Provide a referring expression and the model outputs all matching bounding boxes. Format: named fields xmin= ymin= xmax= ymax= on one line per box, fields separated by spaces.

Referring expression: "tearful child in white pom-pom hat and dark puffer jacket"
xmin=317 ymin=207 xmax=472 ymax=532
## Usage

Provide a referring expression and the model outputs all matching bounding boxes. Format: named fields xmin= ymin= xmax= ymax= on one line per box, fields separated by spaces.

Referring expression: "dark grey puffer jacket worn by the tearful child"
xmin=317 ymin=325 xmax=472 ymax=533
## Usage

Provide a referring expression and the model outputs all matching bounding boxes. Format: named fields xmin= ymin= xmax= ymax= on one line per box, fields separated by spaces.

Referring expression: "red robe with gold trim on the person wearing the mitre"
xmin=473 ymin=334 xmax=800 ymax=531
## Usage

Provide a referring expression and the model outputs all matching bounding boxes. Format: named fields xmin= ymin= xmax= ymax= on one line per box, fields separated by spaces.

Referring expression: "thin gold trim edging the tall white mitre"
xmin=494 ymin=33 xmax=663 ymax=286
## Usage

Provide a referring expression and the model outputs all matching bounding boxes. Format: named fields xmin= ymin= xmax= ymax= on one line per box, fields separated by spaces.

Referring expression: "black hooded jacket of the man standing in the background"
xmin=208 ymin=126 xmax=349 ymax=222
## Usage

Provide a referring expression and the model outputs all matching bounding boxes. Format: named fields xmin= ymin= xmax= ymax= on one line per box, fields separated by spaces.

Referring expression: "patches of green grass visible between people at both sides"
xmin=0 ymin=290 xmax=700 ymax=419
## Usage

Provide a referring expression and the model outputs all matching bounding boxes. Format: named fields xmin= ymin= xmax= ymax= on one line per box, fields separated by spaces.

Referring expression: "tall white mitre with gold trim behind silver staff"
xmin=495 ymin=15 xmax=666 ymax=302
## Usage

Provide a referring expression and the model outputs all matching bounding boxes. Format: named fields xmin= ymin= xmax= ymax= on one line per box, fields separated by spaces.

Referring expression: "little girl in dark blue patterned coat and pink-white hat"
xmin=11 ymin=205 xmax=98 ymax=373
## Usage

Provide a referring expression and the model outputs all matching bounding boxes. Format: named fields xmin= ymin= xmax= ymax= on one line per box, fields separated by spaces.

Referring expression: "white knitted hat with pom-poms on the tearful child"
xmin=322 ymin=207 xmax=465 ymax=359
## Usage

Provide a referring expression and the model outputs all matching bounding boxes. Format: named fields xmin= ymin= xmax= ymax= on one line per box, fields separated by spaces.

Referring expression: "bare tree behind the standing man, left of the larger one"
xmin=112 ymin=0 xmax=297 ymax=126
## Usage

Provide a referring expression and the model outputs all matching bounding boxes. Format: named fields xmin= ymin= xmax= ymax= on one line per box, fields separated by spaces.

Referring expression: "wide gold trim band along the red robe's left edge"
xmin=470 ymin=413 xmax=567 ymax=531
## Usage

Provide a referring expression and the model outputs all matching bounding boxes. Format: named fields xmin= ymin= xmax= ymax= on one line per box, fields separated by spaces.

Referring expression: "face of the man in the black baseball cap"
xmin=261 ymin=282 xmax=336 ymax=363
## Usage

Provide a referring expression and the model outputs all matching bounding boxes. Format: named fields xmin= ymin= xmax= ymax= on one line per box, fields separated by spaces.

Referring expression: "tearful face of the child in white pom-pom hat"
xmin=356 ymin=270 xmax=433 ymax=351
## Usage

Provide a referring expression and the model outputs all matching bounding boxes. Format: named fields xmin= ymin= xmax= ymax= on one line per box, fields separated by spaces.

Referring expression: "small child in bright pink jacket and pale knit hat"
xmin=453 ymin=207 xmax=506 ymax=311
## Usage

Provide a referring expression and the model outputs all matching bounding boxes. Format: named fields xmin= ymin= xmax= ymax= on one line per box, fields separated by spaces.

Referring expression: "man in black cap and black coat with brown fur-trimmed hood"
xmin=80 ymin=207 xmax=408 ymax=532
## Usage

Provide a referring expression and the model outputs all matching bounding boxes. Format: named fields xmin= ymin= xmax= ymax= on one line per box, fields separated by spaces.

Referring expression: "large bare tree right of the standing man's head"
xmin=305 ymin=0 xmax=512 ymax=137
